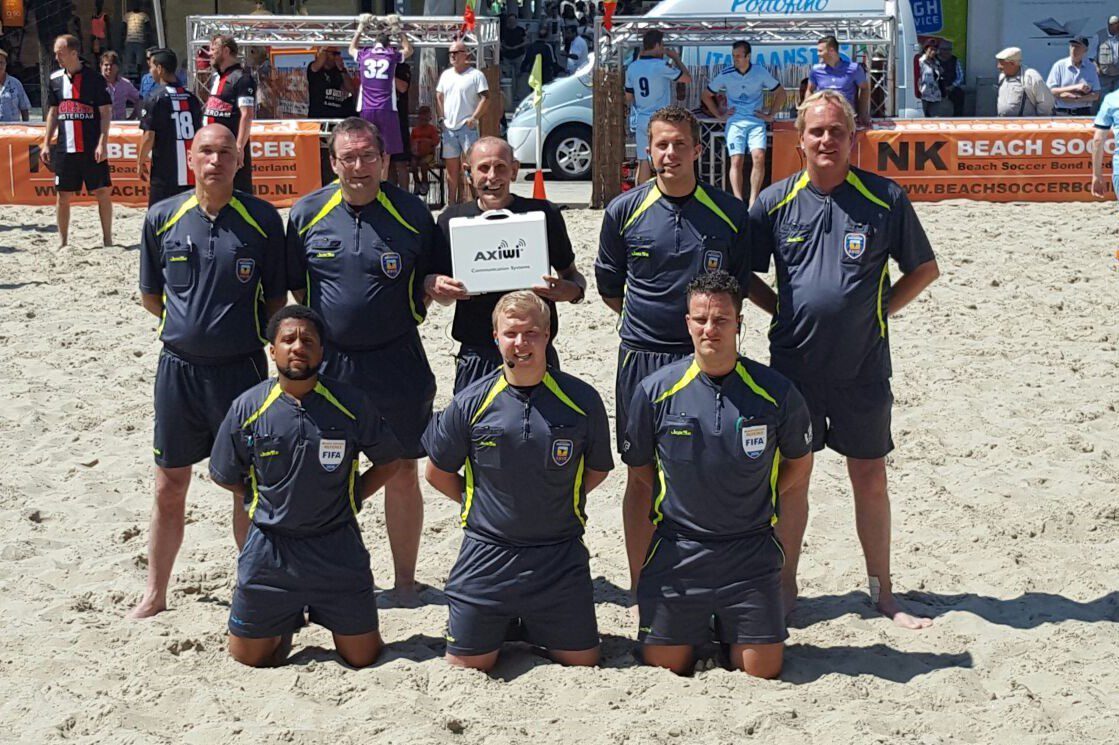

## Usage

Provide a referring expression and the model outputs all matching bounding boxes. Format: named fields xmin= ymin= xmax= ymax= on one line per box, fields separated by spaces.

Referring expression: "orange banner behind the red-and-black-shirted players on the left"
xmin=0 ymin=121 xmax=322 ymax=207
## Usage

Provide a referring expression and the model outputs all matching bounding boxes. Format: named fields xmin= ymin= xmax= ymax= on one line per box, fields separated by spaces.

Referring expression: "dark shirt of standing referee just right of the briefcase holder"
xmin=594 ymin=180 xmax=750 ymax=353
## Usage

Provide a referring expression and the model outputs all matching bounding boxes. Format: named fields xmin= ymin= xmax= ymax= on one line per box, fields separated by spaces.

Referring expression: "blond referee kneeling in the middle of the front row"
xmin=424 ymin=290 xmax=614 ymax=670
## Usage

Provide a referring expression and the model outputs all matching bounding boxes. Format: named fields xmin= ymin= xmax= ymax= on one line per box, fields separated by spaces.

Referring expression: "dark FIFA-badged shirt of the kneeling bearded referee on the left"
xmin=209 ymin=379 xmax=401 ymax=536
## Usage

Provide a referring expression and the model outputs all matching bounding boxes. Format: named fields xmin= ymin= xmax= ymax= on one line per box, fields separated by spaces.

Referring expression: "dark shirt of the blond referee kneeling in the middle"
xmin=423 ymin=370 xmax=614 ymax=546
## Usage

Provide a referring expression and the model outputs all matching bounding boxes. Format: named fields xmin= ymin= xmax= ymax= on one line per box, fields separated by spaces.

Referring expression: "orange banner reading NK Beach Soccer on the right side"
xmin=772 ymin=119 xmax=1116 ymax=201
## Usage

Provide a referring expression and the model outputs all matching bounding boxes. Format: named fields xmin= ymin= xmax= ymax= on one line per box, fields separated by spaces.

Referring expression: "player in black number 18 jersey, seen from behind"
xmin=137 ymin=49 xmax=201 ymax=207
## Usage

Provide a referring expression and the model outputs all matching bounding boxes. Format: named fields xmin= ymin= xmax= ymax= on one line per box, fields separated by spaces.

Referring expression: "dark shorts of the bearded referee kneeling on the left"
xmin=228 ymin=520 xmax=378 ymax=639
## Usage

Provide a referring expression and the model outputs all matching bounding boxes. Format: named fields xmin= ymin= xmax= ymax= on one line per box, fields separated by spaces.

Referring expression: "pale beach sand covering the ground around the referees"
xmin=0 ymin=196 xmax=1119 ymax=745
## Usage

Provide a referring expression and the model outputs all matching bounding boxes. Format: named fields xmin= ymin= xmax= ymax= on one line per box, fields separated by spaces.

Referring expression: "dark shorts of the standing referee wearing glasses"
xmin=322 ymin=330 xmax=435 ymax=460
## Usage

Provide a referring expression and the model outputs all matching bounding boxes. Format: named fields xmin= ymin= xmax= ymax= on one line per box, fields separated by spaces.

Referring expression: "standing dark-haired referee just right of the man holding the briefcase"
xmin=594 ymin=106 xmax=750 ymax=587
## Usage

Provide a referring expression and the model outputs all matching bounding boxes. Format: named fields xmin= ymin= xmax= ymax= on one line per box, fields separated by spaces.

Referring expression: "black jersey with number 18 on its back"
xmin=140 ymin=85 xmax=203 ymax=187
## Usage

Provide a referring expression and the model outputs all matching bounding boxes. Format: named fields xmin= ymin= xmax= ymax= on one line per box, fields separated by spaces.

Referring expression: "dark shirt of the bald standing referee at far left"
xmin=140 ymin=185 xmax=288 ymax=365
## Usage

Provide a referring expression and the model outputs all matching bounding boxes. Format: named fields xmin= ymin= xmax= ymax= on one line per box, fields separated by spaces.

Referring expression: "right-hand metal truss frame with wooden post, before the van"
xmin=591 ymin=12 xmax=899 ymax=208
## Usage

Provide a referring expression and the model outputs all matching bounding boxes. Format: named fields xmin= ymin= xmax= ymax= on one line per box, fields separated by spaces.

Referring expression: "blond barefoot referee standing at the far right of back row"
xmin=750 ymin=91 xmax=940 ymax=629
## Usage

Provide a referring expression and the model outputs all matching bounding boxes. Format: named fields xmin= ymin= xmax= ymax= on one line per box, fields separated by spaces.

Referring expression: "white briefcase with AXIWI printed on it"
xmin=450 ymin=209 xmax=551 ymax=295
